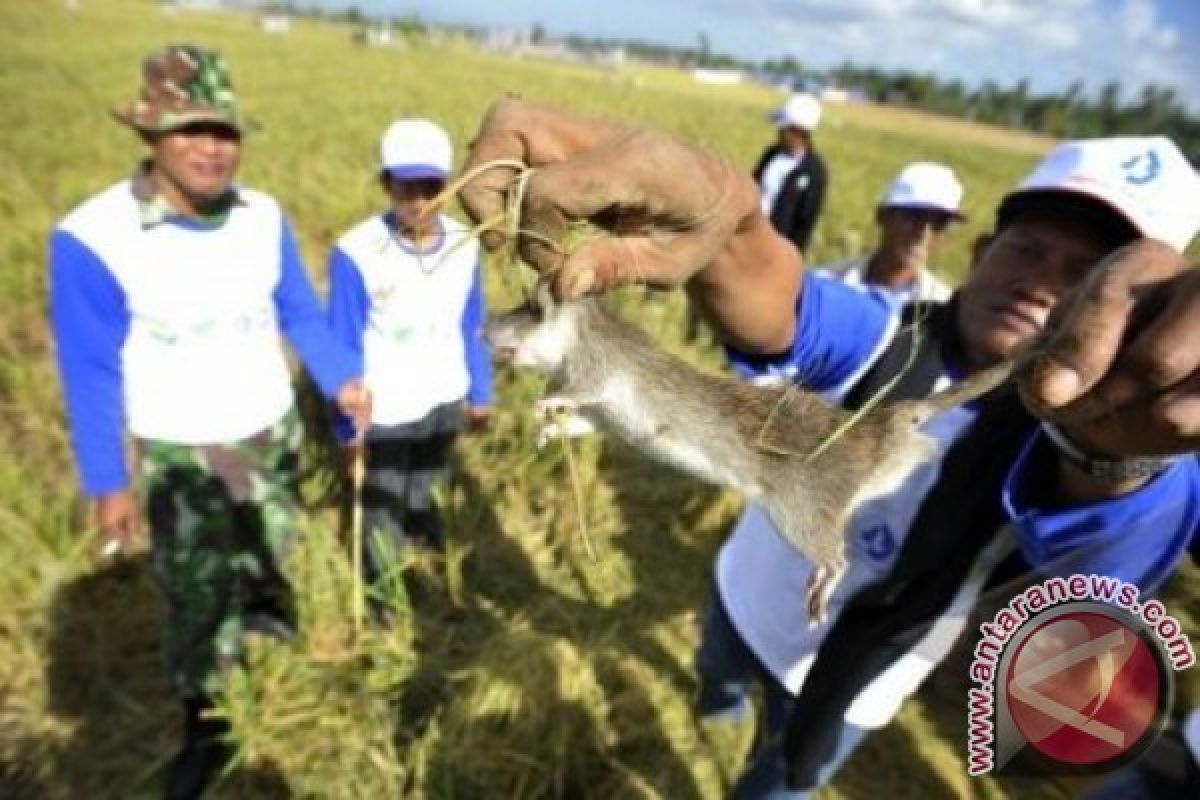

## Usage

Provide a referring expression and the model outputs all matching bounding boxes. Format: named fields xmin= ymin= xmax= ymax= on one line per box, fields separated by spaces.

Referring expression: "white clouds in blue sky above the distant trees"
xmin=689 ymin=0 xmax=1200 ymax=110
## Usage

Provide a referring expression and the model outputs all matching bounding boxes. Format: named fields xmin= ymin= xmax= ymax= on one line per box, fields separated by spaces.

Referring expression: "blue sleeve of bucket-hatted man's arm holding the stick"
xmin=275 ymin=219 xmax=362 ymax=397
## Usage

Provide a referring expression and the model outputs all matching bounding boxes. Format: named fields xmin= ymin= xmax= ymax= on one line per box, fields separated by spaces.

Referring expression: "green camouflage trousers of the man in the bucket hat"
xmin=139 ymin=410 xmax=304 ymax=697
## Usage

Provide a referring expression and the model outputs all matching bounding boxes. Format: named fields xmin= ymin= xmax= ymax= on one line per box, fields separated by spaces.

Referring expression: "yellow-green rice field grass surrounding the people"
xmin=0 ymin=0 xmax=1200 ymax=800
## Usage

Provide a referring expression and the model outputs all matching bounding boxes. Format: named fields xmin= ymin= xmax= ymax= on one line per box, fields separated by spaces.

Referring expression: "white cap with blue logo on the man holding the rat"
xmin=1001 ymin=136 xmax=1200 ymax=252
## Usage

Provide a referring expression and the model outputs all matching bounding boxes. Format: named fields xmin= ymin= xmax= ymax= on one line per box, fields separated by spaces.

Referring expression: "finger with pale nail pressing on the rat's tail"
xmin=1022 ymin=240 xmax=1180 ymax=413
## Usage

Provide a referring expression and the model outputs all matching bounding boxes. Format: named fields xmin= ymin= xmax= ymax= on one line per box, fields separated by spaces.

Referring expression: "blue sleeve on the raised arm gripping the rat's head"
xmin=726 ymin=271 xmax=895 ymax=391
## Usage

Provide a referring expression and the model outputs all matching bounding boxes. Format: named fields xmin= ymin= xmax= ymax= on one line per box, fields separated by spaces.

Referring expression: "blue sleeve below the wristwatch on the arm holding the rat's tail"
xmin=1003 ymin=431 xmax=1200 ymax=593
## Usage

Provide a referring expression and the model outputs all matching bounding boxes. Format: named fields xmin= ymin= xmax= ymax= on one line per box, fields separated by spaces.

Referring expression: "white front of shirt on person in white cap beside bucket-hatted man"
xmin=337 ymin=215 xmax=479 ymax=425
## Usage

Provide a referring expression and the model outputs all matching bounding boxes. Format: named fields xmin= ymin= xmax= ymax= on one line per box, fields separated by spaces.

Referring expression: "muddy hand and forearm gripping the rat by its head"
xmin=460 ymin=100 xmax=803 ymax=353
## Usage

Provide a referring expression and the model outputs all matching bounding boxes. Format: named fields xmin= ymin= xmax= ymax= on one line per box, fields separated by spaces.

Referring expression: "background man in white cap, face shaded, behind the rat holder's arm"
xmin=816 ymin=162 xmax=965 ymax=306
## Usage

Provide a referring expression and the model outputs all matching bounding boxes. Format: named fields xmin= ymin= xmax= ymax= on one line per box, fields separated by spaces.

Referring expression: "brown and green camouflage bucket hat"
xmin=113 ymin=44 xmax=256 ymax=133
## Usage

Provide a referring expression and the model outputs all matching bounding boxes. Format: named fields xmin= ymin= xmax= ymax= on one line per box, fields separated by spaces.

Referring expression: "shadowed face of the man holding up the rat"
xmin=959 ymin=215 xmax=1108 ymax=366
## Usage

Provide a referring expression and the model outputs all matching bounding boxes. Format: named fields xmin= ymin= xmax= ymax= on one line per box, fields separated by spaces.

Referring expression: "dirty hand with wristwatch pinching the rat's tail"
xmin=1020 ymin=239 xmax=1200 ymax=458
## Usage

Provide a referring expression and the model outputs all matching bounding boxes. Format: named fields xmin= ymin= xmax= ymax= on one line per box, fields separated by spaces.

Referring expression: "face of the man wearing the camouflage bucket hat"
xmin=152 ymin=122 xmax=241 ymax=211
